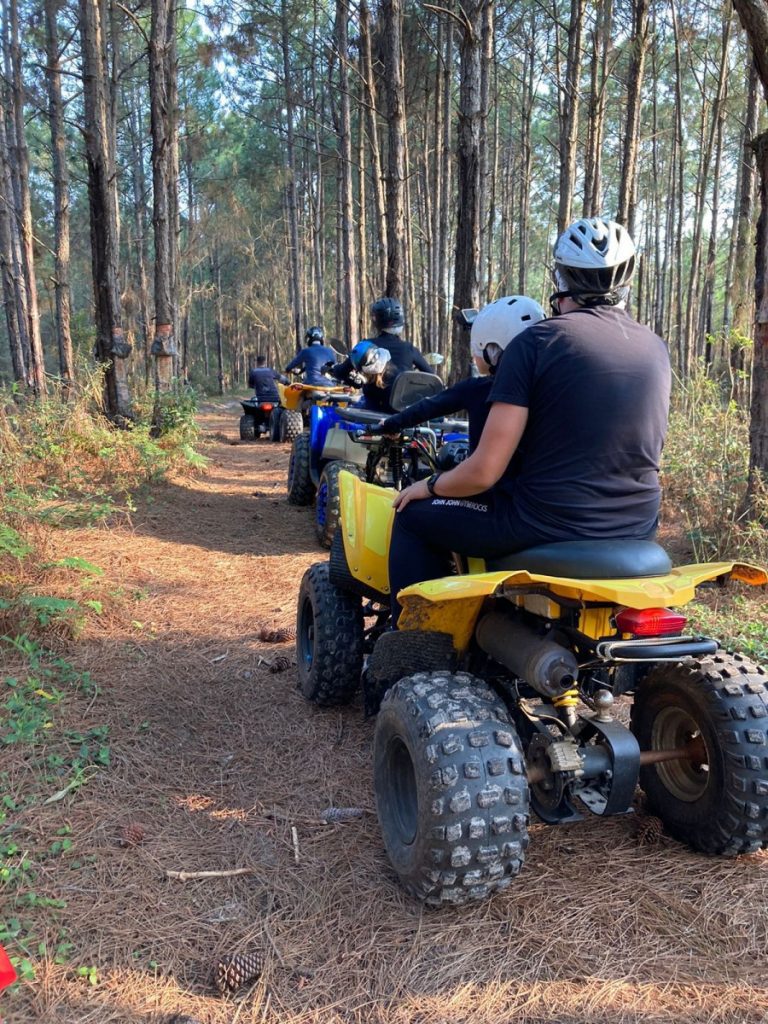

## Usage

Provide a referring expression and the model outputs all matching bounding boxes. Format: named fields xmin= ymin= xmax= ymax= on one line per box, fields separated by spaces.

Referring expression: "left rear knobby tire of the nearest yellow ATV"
xmin=374 ymin=672 xmax=528 ymax=906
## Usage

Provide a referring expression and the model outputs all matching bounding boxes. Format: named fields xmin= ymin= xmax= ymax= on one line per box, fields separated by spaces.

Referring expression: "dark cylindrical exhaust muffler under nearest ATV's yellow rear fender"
xmin=475 ymin=611 xmax=579 ymax=697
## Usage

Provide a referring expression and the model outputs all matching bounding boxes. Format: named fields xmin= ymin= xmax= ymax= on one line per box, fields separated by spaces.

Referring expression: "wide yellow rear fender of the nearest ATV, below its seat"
xmin=397 ymin=562 xmax=768 ymax=650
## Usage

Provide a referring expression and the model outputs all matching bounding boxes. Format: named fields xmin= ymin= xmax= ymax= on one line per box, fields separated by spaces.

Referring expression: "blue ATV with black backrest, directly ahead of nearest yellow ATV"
xmin=288 ymin=371 xmax=467 ymax=548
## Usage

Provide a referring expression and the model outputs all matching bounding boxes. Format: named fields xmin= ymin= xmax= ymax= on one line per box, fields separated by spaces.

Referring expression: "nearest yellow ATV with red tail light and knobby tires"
xmin=297 ymin=473 xmax=768 ymax=905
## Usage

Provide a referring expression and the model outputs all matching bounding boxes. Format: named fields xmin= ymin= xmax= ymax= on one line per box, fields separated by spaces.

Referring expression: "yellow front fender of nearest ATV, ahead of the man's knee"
xmin=339 ymin=472 xmax=394 ymax=594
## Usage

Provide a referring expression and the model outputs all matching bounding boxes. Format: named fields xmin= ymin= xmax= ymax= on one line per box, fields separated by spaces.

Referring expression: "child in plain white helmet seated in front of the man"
xmin=379 ymin=295 xmax=546 ymax=453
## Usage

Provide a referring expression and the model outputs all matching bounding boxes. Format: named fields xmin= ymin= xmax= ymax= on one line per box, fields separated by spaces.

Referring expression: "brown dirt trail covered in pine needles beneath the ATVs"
xmin=8 ymin=406 xmax=768 ymax=1024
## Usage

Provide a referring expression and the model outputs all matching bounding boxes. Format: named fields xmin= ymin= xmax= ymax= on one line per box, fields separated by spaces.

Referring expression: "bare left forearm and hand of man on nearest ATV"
xmin=392 ymin=401 xmax=528 ymax=509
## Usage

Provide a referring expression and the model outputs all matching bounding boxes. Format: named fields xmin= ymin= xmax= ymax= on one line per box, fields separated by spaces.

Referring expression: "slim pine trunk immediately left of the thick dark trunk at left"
xmin=45 ymin=0 xmax=75 ymax=398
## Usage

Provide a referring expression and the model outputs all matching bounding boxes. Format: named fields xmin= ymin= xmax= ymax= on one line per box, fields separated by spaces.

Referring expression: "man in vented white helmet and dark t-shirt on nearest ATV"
xmin=389 ymin=217 xmax=671 ymax=622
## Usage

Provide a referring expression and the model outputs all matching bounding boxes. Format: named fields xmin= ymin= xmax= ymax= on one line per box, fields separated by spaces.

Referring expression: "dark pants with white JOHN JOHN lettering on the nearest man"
xmin=389 ymin=490 xmax=545 ymax=625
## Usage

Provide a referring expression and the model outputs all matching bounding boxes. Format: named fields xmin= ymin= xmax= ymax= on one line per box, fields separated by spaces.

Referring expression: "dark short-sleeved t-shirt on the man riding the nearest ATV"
xmin=488 ymin=306 xmax=671 ymax=542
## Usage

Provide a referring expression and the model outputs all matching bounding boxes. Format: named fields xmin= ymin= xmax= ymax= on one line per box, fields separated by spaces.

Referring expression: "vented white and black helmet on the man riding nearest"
xmin=554 ymin=217 xmax=635 ymax=304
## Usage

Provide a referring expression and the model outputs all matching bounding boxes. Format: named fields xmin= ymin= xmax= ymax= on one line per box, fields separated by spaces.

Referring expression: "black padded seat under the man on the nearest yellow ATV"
xmin=485 ymin=540 xmax=672 ymax=580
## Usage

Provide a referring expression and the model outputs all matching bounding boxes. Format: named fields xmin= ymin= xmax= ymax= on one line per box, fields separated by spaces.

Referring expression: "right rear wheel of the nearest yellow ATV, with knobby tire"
xmin=632 ymin=652 xmax=768 ymax=856
